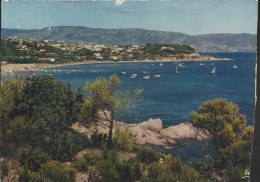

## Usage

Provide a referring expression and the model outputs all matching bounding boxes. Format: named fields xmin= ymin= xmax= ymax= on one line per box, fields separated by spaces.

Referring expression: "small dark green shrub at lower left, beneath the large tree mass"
xmin=18 ymin=147 xmax=49 ymax=172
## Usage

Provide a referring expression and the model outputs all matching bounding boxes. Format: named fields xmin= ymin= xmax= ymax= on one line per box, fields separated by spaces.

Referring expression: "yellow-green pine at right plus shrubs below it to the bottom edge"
xmin=191 ymin=99 xmax=254 ymax=181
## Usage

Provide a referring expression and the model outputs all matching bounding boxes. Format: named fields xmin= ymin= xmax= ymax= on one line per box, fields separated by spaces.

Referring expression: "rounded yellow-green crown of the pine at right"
xmin=191 ymin=99 xmax=246 ymax=148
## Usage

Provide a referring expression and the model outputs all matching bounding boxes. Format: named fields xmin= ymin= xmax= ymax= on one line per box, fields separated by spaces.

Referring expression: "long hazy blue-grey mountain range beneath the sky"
xmin=1 ymin=26 xmax=257 ymax=52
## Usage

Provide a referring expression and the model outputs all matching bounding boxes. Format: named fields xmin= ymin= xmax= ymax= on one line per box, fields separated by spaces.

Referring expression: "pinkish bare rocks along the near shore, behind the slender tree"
xmin=72 ymin=119 xmax=212 ymax=150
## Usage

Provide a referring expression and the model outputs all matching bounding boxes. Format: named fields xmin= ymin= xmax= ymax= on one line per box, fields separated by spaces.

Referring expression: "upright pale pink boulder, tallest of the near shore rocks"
xmin=137 ymin=119 xmax=163 ymax=133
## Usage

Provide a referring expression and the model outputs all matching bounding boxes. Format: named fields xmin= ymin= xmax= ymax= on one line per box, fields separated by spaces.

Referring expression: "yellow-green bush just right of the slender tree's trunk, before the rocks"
xmin=113 ymin=127 xmax=134 ymax=152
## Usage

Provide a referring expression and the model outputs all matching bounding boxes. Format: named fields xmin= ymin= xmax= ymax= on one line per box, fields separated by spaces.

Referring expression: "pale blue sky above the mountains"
xmin=1 ymin=0 xmax=257 ymax=35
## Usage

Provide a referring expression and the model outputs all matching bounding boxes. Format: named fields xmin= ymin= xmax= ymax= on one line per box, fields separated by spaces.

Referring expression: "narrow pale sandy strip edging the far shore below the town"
xmin=1 ymin=56 xmax=232 ymax=75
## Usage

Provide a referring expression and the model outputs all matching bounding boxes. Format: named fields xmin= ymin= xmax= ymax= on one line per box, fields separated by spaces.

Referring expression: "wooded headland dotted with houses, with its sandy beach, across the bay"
xmin=1 ymin=37 xmax=230 ymax=75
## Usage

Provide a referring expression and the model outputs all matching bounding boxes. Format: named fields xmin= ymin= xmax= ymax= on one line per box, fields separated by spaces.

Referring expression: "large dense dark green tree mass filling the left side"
xmin=0 ymin=76 xmax=88 ymax=160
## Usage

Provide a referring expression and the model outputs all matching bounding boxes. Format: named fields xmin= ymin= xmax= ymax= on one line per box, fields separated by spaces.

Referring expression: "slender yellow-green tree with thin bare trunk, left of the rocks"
xmin=81 ymin=74 xmax=142 ymax=148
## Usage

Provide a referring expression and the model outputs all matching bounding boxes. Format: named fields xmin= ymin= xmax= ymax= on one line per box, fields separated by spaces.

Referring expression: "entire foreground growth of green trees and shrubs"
xmin=0 ymin=75 xmax=254 ymax=182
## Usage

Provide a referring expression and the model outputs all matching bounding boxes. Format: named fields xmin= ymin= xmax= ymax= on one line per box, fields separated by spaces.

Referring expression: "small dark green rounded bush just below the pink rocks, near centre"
xmin=137 ymin=148 xmax=159 ymax=164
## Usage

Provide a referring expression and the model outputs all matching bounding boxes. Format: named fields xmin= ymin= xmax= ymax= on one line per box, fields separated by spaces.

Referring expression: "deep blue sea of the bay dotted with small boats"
xmin=2 ymin=52 xmax=256 ymax=162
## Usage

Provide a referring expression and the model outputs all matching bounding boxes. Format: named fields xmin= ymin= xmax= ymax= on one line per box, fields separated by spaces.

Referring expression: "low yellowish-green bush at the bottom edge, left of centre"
xmin=41 ymin=161 xmax=75 ymax=182
